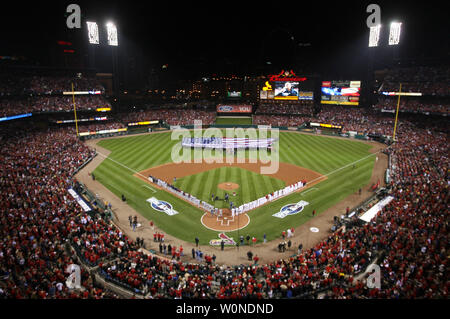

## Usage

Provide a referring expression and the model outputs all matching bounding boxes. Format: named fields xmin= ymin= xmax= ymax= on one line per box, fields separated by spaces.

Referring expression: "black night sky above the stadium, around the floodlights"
xmin=0 ymin=0 xmax=449 ymax=82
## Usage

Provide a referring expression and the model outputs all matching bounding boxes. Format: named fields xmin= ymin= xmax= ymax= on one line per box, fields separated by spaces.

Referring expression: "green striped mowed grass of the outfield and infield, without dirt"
xmin=94 ymin=132 xmax=375 ymax=244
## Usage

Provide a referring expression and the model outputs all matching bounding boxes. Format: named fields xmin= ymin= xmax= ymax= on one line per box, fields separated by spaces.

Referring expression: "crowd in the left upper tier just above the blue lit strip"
xmin=0 ymin=95 xmax=111 ymax=116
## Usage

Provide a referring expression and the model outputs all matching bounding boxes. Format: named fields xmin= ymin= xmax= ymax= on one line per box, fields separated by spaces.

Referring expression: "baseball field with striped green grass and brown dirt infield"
xmin=93 ymin=132 xmax=375 ymax=244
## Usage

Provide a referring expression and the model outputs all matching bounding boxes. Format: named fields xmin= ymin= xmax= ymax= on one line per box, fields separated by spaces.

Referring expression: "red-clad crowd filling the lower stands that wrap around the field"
xmin=0 ymin=110 xmax=450 ymax=299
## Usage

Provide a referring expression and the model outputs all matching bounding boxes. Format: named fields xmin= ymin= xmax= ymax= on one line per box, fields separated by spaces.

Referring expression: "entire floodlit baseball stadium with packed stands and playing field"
xmin=0 ymin=2 xmax=450 ymax=302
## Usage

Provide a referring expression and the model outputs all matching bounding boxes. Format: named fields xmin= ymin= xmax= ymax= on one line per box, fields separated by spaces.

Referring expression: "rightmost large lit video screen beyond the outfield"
xmin=321 ymin=81 xmax=361 ymax=105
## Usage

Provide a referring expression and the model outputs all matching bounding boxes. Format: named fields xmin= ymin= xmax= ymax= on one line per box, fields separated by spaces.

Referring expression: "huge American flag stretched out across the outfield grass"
xmin=181 ymin=137 xmax=275 ymax=149
